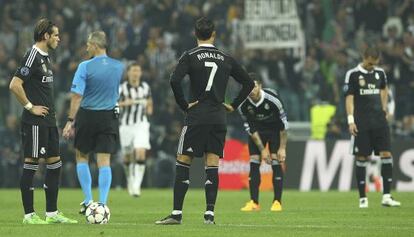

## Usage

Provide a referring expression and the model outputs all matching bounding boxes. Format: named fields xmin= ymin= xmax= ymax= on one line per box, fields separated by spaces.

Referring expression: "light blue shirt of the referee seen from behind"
xmin=71 ymin=55 xmax=124 ymax=110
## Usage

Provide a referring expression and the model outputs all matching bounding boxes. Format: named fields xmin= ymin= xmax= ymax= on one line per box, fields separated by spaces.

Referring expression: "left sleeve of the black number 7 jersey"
xmin=170 ymin=52 xmax=189 ymax=111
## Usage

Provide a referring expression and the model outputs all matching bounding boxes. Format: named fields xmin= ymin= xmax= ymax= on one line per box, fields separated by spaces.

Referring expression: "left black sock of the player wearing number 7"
xmin=173 ymin=160 xmax=190 ymax=211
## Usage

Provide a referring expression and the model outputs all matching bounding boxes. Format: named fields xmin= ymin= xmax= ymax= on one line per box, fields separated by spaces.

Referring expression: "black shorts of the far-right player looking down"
xmin=351 ymin=126 xmax=391 ymax=156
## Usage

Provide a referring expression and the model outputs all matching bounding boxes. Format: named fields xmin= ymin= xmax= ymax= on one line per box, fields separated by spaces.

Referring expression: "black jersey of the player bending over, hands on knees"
xmin=238 ymin=88 xmax=289 ymax=134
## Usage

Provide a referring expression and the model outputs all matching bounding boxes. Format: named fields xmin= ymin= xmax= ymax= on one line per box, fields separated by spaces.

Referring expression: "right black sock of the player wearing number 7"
xmin=204 ymin=166 xmax=219 ymax=212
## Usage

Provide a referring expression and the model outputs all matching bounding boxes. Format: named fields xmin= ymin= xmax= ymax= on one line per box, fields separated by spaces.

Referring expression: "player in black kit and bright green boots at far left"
xmin=10 ymin=18 xmax=77 ymax=224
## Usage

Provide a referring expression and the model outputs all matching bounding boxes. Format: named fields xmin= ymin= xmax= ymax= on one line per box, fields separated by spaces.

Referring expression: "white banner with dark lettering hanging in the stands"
xmin=238 ymin=0 xmax=303 ymax=49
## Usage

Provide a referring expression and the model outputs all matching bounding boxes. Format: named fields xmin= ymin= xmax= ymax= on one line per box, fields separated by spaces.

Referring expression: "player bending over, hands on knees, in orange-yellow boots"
xmin=238 ymin=73 xmax=288 ymax=211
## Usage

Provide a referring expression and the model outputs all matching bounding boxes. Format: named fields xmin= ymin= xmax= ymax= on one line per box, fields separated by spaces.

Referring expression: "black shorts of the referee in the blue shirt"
xmin=75 ymin=108 xmax=119 ymax=154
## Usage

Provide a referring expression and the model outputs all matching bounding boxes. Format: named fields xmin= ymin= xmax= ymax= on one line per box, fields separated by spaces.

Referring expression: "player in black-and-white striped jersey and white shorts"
xmin=119 ymin=63 xmax=153 ymax=197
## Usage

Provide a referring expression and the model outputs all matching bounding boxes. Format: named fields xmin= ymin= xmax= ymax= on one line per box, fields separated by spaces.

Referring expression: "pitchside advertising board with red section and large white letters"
xmin=219 ymin=140 xmax=414 ymax=191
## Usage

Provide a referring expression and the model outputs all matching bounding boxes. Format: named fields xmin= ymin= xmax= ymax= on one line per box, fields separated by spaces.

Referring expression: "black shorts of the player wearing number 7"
xmin=177 ymin=124 xmax=227 ymax=158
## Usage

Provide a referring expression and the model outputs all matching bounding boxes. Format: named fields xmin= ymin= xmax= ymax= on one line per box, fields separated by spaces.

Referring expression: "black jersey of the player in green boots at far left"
xmin=14 ymin=45 xmax=56 ymax=127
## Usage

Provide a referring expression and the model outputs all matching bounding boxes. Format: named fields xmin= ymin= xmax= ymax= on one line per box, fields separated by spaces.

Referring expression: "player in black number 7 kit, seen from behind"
xmin=155 ymin=17 xmax=254 ymax=225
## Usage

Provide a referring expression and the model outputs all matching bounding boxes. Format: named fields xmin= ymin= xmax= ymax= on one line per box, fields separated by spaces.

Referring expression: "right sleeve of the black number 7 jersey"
xmin=230 ymin=59 xmax=254 ymax=109
